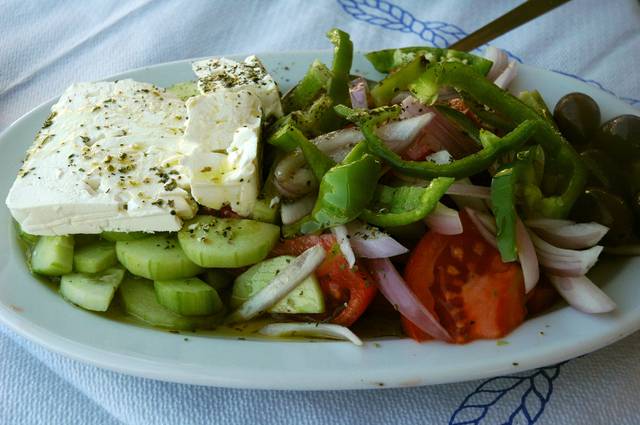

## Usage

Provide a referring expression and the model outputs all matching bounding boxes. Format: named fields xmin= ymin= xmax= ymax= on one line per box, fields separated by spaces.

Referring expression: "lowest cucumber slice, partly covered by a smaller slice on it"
xmin=119 ymin=278 xmax=224 ymax=330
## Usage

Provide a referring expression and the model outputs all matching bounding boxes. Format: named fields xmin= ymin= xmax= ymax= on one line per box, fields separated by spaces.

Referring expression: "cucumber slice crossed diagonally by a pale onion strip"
xmin=231 ymin=255 xmax=324 ymax=313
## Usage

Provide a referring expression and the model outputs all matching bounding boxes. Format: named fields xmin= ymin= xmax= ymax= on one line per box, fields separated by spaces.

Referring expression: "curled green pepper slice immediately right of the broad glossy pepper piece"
xmin=360 ymin=177 xmax=455 ymax=227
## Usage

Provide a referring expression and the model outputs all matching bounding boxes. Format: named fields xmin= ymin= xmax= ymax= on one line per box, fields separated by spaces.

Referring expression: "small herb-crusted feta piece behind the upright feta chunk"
xmin=192 ymin=56 xmax=282 ymax=118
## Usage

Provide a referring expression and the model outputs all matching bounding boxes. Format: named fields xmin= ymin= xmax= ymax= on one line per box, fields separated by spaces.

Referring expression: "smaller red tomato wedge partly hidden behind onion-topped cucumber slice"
xmin=272 ymin=235 xmax=378 ymax=326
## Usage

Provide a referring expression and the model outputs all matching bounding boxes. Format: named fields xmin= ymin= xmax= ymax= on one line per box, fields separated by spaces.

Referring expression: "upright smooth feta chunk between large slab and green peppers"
xmin=181 ymin=90 xmax=262 ymax=216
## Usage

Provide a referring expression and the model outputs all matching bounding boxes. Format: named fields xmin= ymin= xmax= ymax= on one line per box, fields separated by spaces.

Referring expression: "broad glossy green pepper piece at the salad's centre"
xmin=301 ymin=154 xmax=381 ymax=233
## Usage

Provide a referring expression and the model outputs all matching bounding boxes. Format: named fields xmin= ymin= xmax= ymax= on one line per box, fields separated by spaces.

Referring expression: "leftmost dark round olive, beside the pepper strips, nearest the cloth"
xmin=553 ymin=93 xmax=600 ymax=146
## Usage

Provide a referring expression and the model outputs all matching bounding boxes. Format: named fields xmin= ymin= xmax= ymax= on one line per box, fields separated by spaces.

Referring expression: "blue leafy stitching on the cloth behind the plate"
xmin=337 ymin=0 xmax=640 ymax=106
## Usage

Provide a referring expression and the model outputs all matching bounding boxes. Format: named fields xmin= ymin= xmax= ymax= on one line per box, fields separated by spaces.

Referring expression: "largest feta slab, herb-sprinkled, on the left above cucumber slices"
xmin=6 ymin=80 xmax=197 ymax=235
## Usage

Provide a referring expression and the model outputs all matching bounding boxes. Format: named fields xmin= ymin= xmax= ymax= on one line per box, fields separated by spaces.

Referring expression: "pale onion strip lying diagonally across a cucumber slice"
xmin=226 ymin=245 xmax=326 ymax=323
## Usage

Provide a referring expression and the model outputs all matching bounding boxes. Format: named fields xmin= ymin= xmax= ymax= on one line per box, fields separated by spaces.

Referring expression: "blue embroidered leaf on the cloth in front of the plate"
xmin=449 ymin=364 xmax=561 ymax=425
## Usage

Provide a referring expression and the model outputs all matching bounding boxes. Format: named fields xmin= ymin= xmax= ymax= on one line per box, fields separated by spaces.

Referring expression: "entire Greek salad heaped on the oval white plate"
xmin=6 ymin=29 xmax=640 ymax=344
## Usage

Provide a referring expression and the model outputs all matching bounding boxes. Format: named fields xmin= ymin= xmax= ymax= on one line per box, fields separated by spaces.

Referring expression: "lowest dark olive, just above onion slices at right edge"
xmin=571 ymin=187 xmax=634 ymax=245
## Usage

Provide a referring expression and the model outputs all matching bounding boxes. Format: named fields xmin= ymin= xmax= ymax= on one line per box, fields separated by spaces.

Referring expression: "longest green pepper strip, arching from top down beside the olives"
xmin=408 ymin=62 xmax=587 ymax=218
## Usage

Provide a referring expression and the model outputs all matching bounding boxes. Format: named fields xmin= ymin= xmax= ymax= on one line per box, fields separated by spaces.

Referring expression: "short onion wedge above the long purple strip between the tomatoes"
xmin=347 ymin=220 xmax=409 ymax=258
